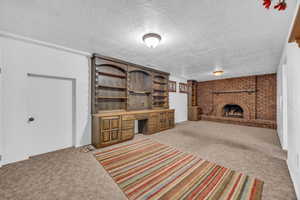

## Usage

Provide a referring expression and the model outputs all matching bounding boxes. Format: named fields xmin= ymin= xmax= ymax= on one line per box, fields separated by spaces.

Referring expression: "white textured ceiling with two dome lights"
xmin=0 ymin=0 xmax=296 ymax=80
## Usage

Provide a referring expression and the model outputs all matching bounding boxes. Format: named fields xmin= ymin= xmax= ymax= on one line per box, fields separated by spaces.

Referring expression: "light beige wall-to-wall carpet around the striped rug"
xmin=0 ymin=121 xmax=296 ymax=200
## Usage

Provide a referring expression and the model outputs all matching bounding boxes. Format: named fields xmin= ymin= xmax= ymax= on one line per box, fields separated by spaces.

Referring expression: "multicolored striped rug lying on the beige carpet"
xmin=95 ymin=139 xmax=263 ymax=200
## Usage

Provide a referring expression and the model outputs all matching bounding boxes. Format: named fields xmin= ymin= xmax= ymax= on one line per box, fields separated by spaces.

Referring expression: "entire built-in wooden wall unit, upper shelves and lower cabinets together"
xmin=91 ymin=54 xmax=174 ymax=148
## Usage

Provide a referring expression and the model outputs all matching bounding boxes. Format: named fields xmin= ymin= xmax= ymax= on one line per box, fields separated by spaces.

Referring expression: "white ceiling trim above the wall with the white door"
xmin=0 ymin=30 xmax=92 ymax=57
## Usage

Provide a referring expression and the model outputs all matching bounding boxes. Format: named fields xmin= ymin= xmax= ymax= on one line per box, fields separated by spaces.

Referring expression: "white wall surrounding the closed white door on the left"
xmin=0 ymin=37 xmax=91 ymax=163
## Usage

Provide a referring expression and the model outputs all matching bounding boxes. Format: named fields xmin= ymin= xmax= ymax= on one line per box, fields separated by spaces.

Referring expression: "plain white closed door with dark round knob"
xmin=27 ymin=75 xmax=74 ymax=156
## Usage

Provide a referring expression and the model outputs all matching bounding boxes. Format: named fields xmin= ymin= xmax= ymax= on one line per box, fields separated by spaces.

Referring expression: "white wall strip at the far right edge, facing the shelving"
xmin=286 ymin=43 xmax=300 ymax=198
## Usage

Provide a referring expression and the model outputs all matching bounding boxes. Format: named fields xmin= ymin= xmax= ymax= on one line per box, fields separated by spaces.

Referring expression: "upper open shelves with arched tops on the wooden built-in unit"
xmin=92 ymin=55 xmax=169 ymax=113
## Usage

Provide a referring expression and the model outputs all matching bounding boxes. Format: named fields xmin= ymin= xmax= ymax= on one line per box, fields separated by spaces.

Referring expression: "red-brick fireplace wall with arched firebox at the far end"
xmin=197 ymin=74 xmax=276 ymax=129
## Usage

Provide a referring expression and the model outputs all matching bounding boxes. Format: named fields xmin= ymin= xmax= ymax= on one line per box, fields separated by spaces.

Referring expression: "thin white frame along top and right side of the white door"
xmin=27 ymin=73 xmax=77 ymax=147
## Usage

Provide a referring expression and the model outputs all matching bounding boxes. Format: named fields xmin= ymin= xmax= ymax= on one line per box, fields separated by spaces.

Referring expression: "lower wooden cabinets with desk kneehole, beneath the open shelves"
xmin=92 ymin=109 xmax=174 ymax=148
